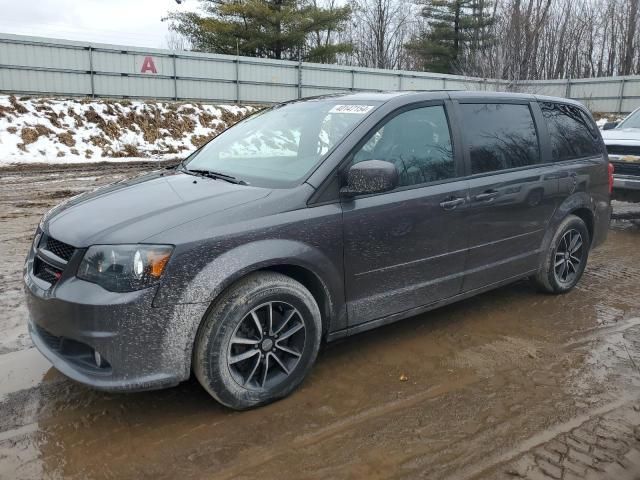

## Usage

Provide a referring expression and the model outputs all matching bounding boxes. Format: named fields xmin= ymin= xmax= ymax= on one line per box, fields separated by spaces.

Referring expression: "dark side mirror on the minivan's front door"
xmin=340 ymin=160 xmax=398 ymax=196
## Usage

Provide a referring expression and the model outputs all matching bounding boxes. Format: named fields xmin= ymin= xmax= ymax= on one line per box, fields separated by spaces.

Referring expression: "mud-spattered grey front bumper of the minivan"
xmin=24 ymin=261 xmax=206 ymax=391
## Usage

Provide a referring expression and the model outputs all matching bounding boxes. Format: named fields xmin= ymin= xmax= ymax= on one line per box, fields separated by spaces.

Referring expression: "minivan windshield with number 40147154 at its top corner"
xmin=186 ymin=99 xmax=381 ymax=188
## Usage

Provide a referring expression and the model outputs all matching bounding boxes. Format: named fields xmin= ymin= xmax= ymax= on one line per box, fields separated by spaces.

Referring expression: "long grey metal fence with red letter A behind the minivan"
xmin=0 ymin=34 xmax=640 ymax=112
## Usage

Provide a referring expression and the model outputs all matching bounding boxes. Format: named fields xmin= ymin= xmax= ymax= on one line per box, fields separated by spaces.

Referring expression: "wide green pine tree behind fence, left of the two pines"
xmin=165 ymin=0 xmax=351 ymax=61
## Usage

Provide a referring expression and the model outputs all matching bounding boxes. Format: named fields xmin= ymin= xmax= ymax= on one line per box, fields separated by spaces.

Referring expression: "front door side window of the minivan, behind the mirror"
xmin=353 ymin=105 xmax=455 ymax=186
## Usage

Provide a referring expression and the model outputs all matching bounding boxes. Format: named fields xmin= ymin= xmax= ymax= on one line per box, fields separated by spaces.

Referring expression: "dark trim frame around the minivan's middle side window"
xmin=452 ymin=98 xmax=547 ymax=179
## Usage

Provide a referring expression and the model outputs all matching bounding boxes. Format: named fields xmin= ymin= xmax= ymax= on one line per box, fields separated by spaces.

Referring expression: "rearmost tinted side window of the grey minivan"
xmin=540 ymin=102 xmax=602 ymax=162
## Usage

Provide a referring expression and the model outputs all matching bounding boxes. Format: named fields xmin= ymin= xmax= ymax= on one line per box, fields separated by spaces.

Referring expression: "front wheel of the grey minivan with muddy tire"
xmin=193 ymin=272 xmax=322 ymax=410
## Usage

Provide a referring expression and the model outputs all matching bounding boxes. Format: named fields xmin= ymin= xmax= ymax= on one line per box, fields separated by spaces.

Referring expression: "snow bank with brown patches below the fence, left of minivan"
xmin=0 ymin=95 xmax=257 ymax=165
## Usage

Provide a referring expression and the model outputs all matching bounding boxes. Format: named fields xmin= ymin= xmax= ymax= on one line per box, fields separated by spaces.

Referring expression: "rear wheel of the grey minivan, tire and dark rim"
xmin=533 ymin=215 xmax=591 ymax=294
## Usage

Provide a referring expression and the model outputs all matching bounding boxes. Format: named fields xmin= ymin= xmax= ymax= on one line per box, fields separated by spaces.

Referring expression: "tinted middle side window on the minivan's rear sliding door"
xmin=460 ymin=103 xmax=540 ymax=174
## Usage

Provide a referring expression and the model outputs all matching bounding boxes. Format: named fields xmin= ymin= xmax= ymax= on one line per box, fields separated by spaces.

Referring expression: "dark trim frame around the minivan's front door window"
xmin=327 ymin=99 xmax=464 ymax=200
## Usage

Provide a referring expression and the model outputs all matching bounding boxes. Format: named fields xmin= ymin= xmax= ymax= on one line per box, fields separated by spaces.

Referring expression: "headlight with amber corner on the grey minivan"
xmin=77 ymin=245 xmax=173 ymax=292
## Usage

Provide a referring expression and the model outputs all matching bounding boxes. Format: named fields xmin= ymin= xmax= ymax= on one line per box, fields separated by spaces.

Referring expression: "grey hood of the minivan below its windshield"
xmin=43 ymin=171 xmax=271 ymax=247
